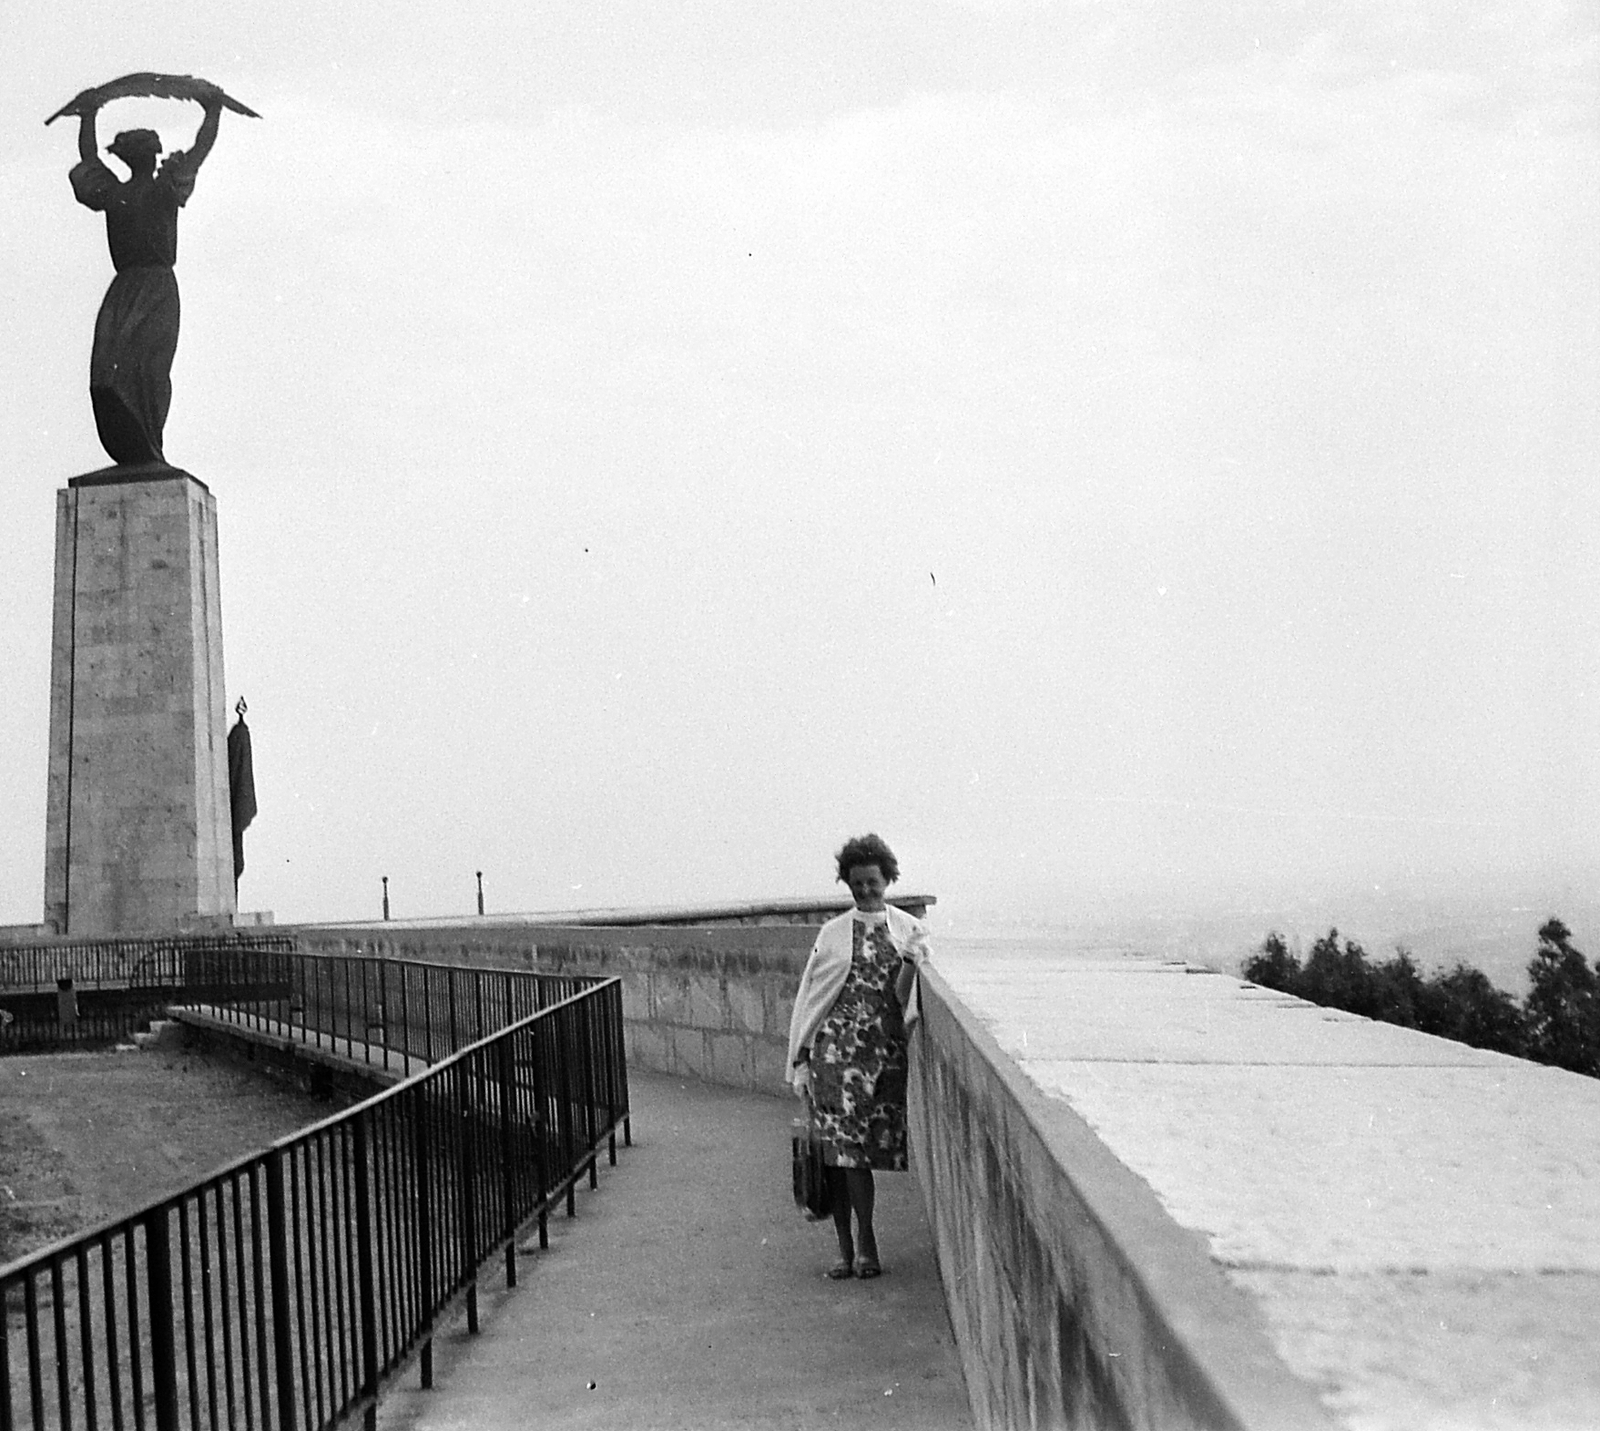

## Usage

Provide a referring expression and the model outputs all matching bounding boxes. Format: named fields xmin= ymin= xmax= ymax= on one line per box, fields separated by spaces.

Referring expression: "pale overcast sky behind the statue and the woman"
xmin=0 ymin=0 xmax=1600 ymax=925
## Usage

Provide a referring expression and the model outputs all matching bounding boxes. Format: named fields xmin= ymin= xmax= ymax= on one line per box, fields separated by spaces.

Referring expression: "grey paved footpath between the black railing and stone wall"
xmin=378 ymin=1072 xmax=971 ymax=1431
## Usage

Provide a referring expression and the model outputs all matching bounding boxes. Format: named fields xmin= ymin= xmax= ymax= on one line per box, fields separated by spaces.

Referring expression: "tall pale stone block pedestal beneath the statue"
xmin=45 ymin=467 xmax=235 ymax=936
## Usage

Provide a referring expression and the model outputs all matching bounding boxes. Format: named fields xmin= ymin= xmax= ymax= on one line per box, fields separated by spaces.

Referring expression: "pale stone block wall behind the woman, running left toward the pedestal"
xmin=278 ymin=920 xmax=816 ymax=1095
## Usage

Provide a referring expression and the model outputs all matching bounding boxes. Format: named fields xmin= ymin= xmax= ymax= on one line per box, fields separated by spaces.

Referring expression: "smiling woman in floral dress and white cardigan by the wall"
xmin=789 ymin=834 xmax=928 ymax=1279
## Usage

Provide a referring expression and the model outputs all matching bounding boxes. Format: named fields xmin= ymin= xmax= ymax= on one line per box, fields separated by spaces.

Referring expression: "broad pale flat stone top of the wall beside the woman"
xmin=936 ymin=940 xmax=1600 ymax=1431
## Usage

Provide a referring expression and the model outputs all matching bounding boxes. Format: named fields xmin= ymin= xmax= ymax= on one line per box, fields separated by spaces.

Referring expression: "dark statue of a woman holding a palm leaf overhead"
xmin=45 ymin=74 xmax=254 ymax=466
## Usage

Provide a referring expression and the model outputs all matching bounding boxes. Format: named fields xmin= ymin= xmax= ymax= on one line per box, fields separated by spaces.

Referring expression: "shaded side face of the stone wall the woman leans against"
xmin=910 ymin=970 xmax=1333 ymax=1431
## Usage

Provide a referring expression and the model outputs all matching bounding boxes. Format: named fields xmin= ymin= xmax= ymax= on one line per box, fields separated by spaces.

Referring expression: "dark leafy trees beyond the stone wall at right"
xmin=1243 ymin=919 xmax=1600 ymax=1077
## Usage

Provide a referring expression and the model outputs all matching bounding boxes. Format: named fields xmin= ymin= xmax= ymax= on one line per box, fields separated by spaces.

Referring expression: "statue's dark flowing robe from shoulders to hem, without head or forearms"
xmin=70 ymin=154 xmax=195 ymax=463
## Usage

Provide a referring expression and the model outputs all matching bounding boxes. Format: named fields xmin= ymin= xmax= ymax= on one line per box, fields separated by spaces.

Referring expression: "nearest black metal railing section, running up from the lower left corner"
xmin=0 ymin=975 xmax=629 ymax=1431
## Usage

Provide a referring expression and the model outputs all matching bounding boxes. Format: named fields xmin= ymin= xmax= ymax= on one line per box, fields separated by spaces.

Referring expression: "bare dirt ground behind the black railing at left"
xmin=0 ymin=1048 xmax=348 ymax=1266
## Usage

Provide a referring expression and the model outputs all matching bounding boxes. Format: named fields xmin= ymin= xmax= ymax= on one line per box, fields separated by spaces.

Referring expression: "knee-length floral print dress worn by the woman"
xmin=811 ymin=916 xmax=906 ymax=1173
